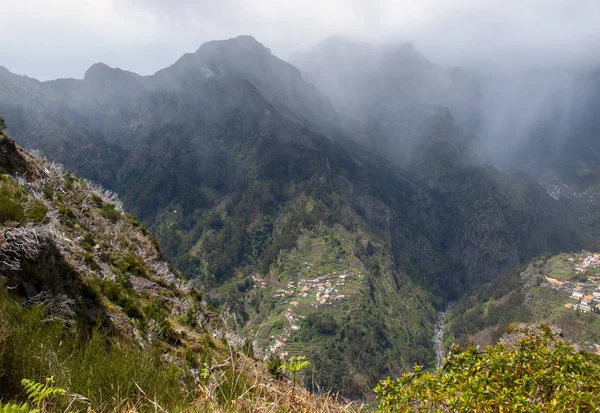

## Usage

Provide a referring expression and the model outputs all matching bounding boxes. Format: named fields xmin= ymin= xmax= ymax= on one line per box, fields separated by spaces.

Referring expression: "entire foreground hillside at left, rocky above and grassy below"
xmin=0 ymin=132 xmax=360 ymax=412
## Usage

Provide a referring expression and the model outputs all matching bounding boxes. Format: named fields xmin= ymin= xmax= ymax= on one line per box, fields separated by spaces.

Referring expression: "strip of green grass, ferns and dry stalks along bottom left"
xmin=0 ymin=286 xmax=355 ymax=413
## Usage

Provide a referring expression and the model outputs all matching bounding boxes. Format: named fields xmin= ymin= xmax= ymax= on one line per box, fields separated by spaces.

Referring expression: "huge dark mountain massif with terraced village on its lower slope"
xmin=0 ymin=36 xmax=590 ymax=397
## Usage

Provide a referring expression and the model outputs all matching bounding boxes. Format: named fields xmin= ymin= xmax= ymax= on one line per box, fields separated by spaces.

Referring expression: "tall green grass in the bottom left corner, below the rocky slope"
xmin=0 ymin=286 xmax=190 ymax=411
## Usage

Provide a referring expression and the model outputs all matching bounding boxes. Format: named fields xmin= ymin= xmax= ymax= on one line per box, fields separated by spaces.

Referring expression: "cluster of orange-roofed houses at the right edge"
xmin=545 ymin=252 xmax=600 ymax=315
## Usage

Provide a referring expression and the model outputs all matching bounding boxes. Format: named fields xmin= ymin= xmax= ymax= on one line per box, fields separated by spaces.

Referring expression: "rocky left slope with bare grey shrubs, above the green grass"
xmin=0 ymin=136 xmax=216 ymax=346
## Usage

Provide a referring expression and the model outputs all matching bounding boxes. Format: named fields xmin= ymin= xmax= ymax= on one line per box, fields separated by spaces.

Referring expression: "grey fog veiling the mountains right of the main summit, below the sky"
xmin=292 ymin=36 xmax=598 ymax=176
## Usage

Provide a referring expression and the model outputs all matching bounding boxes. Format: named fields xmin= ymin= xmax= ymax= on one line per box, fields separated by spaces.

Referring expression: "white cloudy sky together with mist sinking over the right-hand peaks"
xmin=0 ymin=0 xmax=600 ymax=179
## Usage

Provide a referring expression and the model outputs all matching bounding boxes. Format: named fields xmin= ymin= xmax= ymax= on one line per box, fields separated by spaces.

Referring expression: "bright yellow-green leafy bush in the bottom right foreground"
xmin=375 ymin=329 xmax=600 ymax=412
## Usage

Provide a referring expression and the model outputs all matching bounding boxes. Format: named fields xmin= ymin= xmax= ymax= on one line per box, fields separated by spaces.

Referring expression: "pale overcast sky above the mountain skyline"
xmin=0 ymin=0 xmax=600 ymax=80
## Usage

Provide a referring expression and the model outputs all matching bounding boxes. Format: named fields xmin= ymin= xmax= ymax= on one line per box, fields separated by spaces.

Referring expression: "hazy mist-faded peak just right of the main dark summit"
xmin=293 ymin=36 xmax=478 ymax=162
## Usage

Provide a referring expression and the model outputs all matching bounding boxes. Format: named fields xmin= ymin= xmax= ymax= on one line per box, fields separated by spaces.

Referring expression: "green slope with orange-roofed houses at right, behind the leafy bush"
xmin=445 ymin=251 xmax=600 ymax=353
